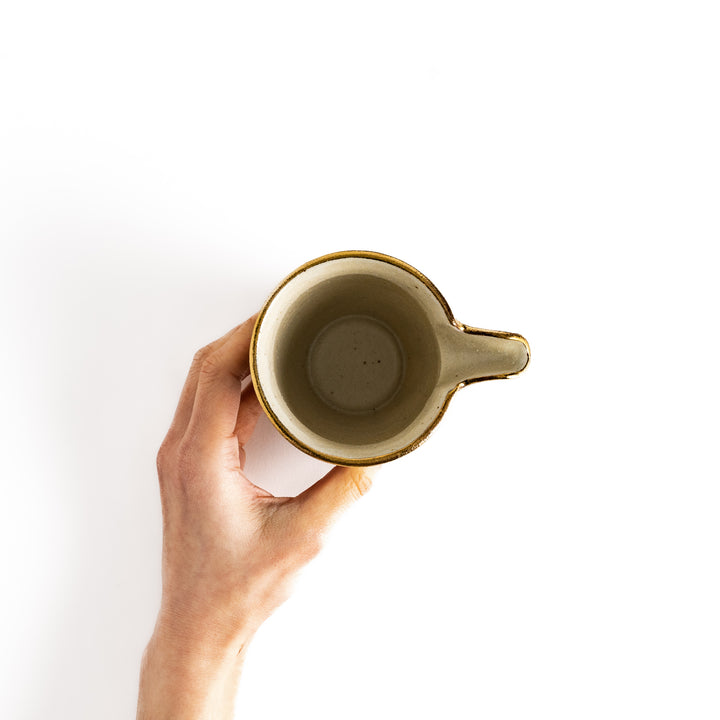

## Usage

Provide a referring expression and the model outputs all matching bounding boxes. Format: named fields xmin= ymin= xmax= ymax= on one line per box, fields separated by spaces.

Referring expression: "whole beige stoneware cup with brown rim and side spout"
xmin=250 ymin=251 xmax=530 ymax=465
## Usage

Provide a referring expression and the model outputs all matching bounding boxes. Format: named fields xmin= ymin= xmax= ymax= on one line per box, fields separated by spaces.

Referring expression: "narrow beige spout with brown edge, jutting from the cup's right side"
xmin=438 ymin=321 xmax=530 ymax=387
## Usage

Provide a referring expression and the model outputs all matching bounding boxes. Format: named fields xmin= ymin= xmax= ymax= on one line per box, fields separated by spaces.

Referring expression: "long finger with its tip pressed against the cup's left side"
xmin=188 ymin=316 xmax=256 ymax=442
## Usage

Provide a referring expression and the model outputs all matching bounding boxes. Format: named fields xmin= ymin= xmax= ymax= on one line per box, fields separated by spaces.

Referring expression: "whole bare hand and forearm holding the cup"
xmin=137 ymin=317 xmax=380 ymax=720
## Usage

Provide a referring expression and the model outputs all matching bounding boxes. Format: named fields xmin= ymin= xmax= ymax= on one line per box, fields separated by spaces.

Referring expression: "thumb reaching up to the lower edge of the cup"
xmin=295 ymin=465 xmax=378 ymax=531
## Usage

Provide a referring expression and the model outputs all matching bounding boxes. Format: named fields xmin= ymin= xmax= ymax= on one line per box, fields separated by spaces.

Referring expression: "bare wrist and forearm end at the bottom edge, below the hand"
xmin=137 ymin=630 xmax=252 ymax=720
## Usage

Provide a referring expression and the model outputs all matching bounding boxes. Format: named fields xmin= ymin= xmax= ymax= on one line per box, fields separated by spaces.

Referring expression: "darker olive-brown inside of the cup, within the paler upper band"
xmin=273 ymin=271 xmax=440 ymax=446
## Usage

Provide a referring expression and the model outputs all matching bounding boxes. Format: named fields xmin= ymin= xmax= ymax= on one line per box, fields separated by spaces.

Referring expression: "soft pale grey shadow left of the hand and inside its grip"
xmin=18 ymin=246 xmax=312 ymax=720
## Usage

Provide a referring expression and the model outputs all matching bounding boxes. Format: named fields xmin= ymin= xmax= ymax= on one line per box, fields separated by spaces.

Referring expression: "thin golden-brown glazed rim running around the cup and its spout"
xmin=250 ymin=250 xmax=530 ymax=467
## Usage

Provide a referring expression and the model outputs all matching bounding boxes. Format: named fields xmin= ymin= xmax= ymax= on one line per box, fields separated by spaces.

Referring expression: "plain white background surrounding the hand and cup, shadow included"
xmin=0 ymin=0 xmax=720 ymax=720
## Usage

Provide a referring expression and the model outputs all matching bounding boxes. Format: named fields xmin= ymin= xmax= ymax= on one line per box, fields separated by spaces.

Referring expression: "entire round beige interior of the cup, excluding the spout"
xmin=257 ymin=259 xmax=440 ymax=460
